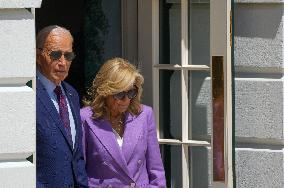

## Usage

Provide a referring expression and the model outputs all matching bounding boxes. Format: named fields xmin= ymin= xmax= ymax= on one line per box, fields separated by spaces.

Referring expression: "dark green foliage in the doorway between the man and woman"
xmin=84 ymin=0 xmax=109 ymax=88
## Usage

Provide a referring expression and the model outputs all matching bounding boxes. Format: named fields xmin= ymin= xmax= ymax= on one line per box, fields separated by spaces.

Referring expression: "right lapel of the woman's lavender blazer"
xmin=122 ymin=113 xmax=144 ymax=163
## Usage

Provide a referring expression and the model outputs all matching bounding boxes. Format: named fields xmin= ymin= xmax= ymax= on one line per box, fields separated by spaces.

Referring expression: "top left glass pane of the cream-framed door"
xmin=159 ymin=0 xmax=181 ymax=64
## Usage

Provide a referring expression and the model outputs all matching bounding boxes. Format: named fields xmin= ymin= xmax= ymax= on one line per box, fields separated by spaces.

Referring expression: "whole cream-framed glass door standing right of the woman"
xmin=152 ymin=0 xmax=232 ymax=188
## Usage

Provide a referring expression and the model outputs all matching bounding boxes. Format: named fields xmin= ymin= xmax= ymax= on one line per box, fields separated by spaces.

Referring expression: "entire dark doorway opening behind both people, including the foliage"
xmin=36 ymin=0 xmax=122 ymax=106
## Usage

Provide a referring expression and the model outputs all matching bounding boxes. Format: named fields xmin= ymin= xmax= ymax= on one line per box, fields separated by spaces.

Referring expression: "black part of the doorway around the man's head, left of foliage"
xmin=35 ymin=0 xmax=86 ymax=103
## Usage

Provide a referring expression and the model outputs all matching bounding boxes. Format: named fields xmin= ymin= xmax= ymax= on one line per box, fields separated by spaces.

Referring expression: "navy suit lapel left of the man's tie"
xmin=36 ymin=79 xmax=72 ymax=150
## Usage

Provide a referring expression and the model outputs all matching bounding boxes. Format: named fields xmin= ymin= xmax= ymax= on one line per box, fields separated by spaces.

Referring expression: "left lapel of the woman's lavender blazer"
xmin=87 ymin=118 xmax=131 ymax=178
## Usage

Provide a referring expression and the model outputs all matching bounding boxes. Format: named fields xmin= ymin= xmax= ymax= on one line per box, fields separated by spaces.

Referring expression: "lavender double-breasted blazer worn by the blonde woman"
xmin=81 ymin=105 xmax=166 ymax=188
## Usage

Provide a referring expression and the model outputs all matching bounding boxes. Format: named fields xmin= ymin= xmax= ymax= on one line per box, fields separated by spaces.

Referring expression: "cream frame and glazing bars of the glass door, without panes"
xmin=149 ymin=0 xmax=234 ymax=188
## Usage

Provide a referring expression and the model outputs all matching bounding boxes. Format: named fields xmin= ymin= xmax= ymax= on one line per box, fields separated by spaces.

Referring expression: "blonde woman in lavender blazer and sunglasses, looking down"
xmin=81 ymin=58 xmax=166 ymax=188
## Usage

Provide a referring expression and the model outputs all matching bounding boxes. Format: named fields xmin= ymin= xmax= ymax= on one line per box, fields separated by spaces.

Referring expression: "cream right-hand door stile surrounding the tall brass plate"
xmin=210 ymin=0 xmax=233 ymax=188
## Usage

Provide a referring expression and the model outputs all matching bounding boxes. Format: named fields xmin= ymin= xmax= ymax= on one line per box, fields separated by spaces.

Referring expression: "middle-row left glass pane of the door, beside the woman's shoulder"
xmin=159 ymin=70 xmax=182 ymax=140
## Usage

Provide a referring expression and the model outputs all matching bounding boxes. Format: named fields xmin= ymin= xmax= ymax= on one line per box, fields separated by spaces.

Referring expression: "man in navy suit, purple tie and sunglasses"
xmin=36 ymin=26 xmax=87 ymax=188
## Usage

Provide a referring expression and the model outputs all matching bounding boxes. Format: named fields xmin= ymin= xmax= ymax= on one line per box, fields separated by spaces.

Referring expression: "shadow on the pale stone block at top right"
xmin=234 ymin=3 xmax=283 ymax=39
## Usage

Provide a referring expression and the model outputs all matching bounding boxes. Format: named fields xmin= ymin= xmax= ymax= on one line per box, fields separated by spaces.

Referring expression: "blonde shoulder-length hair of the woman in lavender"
xmin=85 ymin=58 xmax=144 ymax=119
